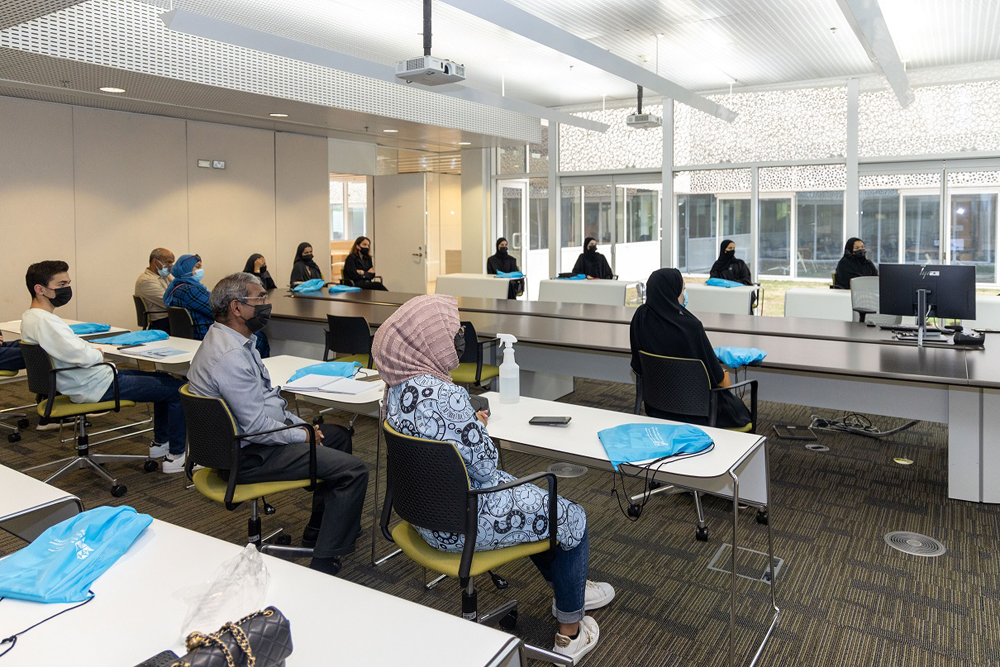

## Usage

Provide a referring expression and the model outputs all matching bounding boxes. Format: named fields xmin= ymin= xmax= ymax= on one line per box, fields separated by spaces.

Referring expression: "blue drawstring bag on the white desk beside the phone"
xmin=597 ymin=424 xmax=715 ymax=470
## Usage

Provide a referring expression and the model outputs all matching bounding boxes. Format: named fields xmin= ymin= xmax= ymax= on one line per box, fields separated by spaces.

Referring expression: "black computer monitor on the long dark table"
xmin=878 ymin=264 xmax=976 ymax=323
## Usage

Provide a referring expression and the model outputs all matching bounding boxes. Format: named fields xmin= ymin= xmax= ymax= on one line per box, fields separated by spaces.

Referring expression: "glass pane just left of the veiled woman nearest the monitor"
xmin=795 ymin=191 xmax=844 ymax=279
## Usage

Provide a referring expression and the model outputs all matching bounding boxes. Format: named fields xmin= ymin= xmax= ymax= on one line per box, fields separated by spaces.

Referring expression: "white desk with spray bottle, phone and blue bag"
xmin=483 ymin=392 xmax=781 ymax=667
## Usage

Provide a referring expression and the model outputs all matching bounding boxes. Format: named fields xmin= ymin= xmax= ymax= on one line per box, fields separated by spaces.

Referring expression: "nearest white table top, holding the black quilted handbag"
xmin=0 ymin=520 xmax=519 ymax=667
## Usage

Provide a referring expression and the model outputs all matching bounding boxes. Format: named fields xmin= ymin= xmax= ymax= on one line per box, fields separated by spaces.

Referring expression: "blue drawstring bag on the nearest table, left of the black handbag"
xmin=0 ymin=507 xmax=153 ymax=602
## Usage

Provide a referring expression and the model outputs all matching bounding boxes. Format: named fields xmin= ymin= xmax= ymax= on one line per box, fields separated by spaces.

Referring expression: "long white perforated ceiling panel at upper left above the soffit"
xmin=0 ymin=0 xmax=541 ymax=142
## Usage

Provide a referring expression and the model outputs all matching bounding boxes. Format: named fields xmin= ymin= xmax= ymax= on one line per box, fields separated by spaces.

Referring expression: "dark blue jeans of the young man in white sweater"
xmin=101 ymin=371 xmax=187 ymax=456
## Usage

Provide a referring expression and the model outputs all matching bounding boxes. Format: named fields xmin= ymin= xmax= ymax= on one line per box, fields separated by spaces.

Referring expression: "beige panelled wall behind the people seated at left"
xmin=0 ymin=97 xmax=329 ymax=328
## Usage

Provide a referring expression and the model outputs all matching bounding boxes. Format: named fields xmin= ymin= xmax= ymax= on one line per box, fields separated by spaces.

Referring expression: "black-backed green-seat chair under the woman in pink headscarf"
xmin=379 ymin=421 xmax=573 ymax=665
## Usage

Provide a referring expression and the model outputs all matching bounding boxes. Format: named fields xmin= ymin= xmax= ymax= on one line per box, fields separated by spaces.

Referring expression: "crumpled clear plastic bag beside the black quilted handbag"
xmin=179 ymin=544 xmax=271 ymax=640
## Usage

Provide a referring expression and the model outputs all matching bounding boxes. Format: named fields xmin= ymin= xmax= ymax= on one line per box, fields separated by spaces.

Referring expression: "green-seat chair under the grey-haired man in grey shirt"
xmin=180 ymin=384 xmax=316 ymax=558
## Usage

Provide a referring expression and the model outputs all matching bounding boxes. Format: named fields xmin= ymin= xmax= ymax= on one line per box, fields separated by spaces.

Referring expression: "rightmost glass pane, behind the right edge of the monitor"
xmin=951 ymin=193 xmax=997 ymax=283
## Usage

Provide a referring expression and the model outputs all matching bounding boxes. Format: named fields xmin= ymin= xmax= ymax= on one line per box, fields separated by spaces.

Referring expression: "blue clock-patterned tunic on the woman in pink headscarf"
xmin=387 ymin=375 xmax=587 ymax=552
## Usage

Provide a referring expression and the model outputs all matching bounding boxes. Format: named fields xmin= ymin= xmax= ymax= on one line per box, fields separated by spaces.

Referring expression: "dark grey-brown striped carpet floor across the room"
xmin=0 ymin=380 xmax=1000 ymax=667
